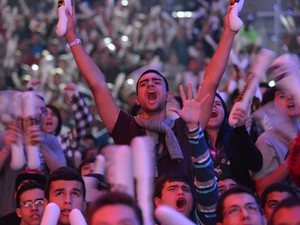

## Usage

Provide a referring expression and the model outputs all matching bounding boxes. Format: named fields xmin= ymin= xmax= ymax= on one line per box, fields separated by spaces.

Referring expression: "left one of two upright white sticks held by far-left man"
xmin=10 ymin=92 xmax=26 ymax=170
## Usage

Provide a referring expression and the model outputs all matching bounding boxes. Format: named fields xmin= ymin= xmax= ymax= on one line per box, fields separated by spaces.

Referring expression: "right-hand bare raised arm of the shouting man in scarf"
xmin=197 ymin=9 xmax=237 ymax=129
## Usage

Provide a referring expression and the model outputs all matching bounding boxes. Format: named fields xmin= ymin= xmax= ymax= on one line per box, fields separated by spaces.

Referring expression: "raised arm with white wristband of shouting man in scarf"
xmin=65 ymin=4 xmax=120 ymax=132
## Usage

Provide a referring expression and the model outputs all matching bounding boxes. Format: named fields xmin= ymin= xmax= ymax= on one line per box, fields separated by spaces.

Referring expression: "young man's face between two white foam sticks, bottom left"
xmin=49 ymin=180 xmax=85 ymax=224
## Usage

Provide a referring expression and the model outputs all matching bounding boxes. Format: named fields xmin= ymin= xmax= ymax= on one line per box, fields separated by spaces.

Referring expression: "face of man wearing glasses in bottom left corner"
xmin=16 ymin=188 xmax=45 ymax=225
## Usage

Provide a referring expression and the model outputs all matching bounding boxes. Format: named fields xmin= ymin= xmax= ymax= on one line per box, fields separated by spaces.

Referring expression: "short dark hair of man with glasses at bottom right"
xmin=216 ymin=185 xmax=262 ymax=223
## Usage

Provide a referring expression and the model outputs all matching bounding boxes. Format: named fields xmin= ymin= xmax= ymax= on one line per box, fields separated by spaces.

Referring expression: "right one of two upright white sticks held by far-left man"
xmin=22 ymin=91 xmax=41 ymax=169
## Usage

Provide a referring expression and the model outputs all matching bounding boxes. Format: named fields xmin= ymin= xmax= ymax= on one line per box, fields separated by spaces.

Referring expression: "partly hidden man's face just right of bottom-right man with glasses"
xmin=264 ymin=191 xmax=291 ymax=223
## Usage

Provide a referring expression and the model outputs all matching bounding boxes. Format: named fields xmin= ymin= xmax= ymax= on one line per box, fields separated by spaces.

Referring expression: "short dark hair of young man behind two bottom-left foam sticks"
xmin=45 ymin=167 xmax=86 ymax=200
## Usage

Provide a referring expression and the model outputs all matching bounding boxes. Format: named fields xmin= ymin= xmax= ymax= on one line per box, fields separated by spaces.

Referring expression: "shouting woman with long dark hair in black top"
xmin=205 ymin=93 xmax=262 ymax=190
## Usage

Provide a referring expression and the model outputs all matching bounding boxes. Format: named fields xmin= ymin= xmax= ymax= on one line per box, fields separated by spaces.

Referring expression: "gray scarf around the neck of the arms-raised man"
xmin=134 ymin=116 xmax=183 ymax=161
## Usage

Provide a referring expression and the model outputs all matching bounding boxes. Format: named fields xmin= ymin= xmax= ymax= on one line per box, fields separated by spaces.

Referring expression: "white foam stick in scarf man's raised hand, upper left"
xmin=56 ymin=0 xmax=72 ymax=37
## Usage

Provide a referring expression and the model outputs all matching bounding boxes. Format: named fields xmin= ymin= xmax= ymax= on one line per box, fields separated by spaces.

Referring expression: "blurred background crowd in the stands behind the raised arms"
xmin=0 ymin=0 xmax=300 ymax=146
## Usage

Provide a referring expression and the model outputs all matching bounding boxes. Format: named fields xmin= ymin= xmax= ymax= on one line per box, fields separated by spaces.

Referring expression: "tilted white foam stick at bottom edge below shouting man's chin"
xmin=155 ymin=205 xmax=195 ymax=225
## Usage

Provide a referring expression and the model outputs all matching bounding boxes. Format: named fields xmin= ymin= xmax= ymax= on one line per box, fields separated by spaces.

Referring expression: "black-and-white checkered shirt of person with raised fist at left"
xmin=58 ymin=94 xmax=92 ymax=167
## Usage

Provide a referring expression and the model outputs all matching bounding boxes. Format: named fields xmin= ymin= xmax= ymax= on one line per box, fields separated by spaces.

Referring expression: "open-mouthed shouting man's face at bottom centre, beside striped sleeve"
xmin=154 ymin=181 xmax=193 ymax=216
